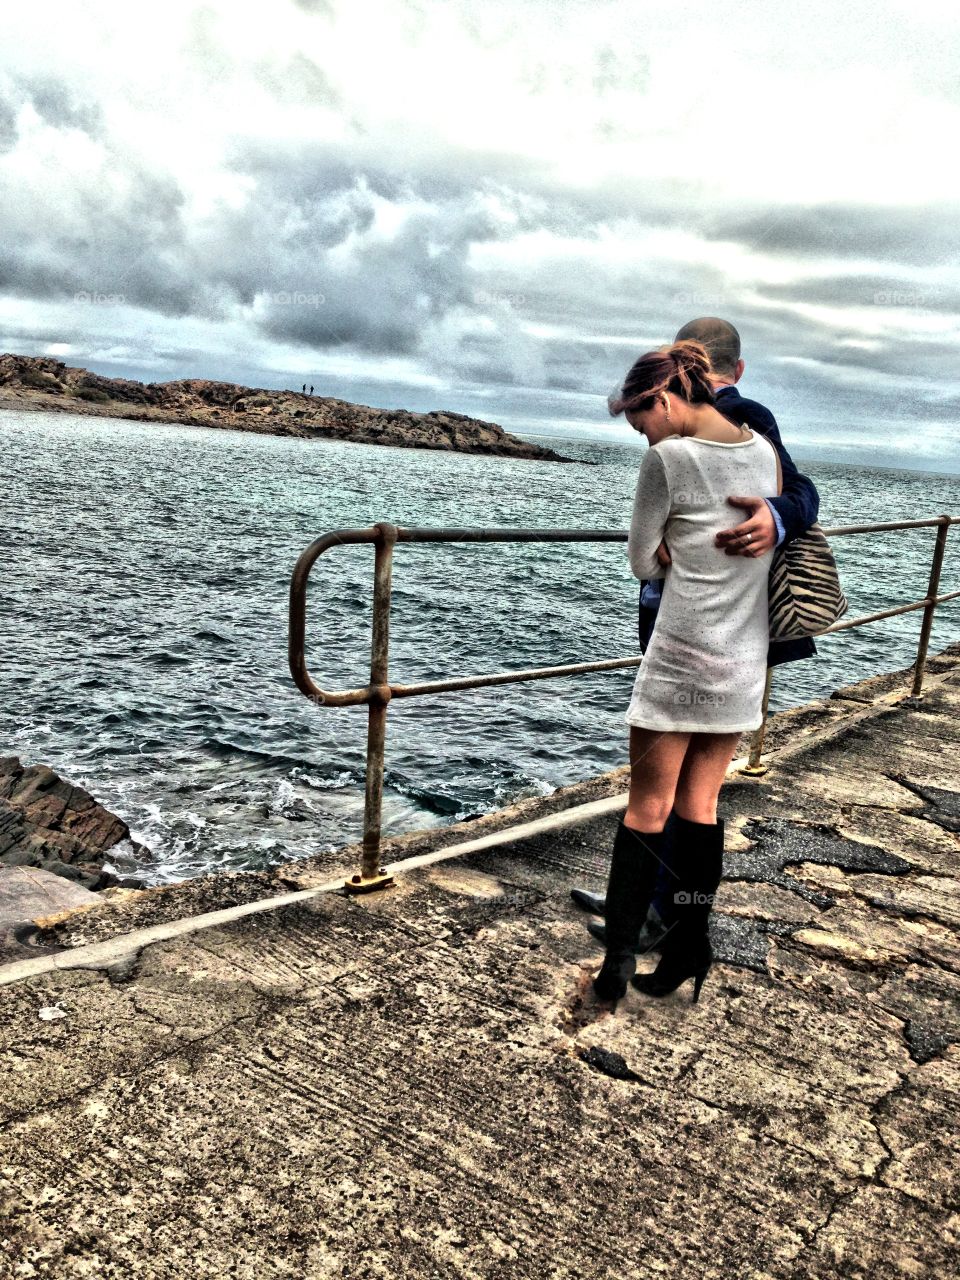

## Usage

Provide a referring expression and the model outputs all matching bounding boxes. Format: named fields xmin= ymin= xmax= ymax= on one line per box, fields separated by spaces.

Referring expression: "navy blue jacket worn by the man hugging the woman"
xmin=639 ymin=387 xmax=820 ymax=667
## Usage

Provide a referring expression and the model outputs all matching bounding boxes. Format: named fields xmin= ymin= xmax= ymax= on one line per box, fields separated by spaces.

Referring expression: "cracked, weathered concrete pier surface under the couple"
xmin=0 ymin=646 xmax=960 ymax=1280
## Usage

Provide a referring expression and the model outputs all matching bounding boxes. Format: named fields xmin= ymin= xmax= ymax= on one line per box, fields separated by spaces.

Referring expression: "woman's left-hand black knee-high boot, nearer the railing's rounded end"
xmin=594 ymin=819 xmax=667 ymax=1001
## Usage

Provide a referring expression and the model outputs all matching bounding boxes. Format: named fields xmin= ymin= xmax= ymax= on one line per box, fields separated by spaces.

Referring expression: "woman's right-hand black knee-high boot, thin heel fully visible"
xmin=632 ymin=817 xmax=723 ymax=1001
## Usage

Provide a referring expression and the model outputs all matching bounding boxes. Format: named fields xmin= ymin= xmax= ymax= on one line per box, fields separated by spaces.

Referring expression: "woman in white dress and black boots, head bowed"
xmin=594 ymin=342 xmax=782 ymax=1001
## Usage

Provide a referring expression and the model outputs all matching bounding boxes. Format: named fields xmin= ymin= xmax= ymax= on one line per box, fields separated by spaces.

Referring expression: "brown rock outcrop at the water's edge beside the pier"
xmin=0 ymin=755 xmax=148 ymax=890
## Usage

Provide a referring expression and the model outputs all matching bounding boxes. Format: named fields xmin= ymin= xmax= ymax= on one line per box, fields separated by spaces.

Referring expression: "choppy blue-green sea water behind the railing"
xmin=0 ymin=412 xmax=960 ymax=883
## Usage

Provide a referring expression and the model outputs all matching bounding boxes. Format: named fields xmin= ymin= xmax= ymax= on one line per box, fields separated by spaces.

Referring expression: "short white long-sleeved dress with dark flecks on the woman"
xmin=626 ymin=431 xmax=777 ymax=733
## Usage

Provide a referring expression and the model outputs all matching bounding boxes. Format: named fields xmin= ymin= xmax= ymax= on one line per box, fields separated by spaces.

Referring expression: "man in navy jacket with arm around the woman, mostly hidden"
xmin=571 ymin=316 xmax=820 ymax=951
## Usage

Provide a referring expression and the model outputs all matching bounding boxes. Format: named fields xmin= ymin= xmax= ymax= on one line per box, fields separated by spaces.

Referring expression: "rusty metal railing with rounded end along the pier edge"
xmin=289 ymin=516 xmax=960 ymax=893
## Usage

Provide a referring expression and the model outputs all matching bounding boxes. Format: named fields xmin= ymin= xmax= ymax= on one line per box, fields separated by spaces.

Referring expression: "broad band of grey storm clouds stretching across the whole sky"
xmin=0 ymin=48 xmax=960 ymax=404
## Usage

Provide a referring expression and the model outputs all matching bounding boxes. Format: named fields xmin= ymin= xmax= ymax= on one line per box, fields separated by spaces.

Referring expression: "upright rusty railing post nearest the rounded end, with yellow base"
xmin=344 ymin=524 xmax=397 ymax=893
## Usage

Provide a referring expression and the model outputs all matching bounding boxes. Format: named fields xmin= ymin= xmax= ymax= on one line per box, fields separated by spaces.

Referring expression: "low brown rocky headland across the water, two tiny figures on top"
xmin=0 ymin=353 xmax=575 ymax=462
